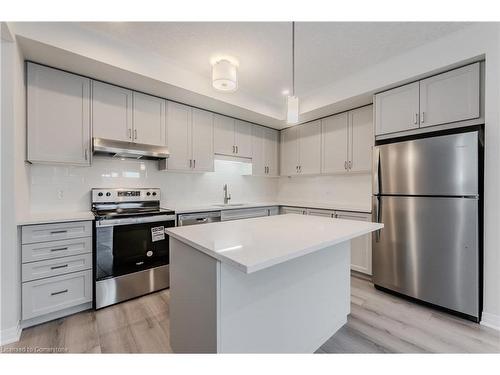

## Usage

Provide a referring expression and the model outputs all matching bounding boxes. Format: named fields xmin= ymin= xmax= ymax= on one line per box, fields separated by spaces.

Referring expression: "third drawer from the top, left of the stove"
xmin=22 ymin=253 xmax=92 ymax=282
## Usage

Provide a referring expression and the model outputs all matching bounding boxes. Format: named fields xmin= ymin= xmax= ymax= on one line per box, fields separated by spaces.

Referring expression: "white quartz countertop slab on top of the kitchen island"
xmin=167 ymin=214 xmax=383 ymax=273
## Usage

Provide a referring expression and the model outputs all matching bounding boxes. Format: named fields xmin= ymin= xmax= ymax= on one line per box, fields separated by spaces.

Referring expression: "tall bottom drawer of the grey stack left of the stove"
xmin=23 ymin=270 xmax=92 ymax=320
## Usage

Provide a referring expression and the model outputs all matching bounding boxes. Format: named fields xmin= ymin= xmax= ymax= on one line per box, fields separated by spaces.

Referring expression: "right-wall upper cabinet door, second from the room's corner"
xmin=299 ymin=120 xmax=321 ymax=174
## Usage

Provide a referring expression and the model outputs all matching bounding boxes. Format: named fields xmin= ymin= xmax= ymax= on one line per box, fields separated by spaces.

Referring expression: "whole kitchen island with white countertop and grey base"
xmin=167 ymin=214 xmax=383 ymax=353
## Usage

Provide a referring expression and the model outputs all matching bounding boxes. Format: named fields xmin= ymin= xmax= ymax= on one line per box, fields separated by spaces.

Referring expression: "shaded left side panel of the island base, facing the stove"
xmin=169 ymin=237 xmax=220 ymax=353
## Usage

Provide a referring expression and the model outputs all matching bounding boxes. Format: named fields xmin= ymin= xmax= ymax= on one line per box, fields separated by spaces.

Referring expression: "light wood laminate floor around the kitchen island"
xmin=3 ymin=277 xmax=500 ymax=353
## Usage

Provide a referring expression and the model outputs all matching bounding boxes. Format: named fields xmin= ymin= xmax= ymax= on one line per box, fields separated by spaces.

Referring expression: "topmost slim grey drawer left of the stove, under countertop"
xmin=22 ymin=221 xmax=92 ymax=244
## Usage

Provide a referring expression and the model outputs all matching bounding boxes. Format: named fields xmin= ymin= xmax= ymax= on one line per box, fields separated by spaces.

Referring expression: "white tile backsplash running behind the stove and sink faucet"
xmin=30 ymin=156 xmax=278 ymax=213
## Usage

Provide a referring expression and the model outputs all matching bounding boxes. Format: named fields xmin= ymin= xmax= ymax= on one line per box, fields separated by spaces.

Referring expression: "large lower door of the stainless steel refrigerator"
xmin=373 ymin=196 xmax=479 ymax=317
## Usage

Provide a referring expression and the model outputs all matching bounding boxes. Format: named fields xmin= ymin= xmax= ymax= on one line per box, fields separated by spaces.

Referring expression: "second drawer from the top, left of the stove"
xmin=22 ymin=237 xmax=92 ymax=263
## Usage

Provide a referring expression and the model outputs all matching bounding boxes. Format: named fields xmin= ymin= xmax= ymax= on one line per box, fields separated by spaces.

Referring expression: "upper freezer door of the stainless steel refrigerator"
xmin=373 ymin=131 xmax=479 ymax=196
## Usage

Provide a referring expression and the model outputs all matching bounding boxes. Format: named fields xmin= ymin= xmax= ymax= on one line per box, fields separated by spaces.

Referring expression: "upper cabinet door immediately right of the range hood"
xmin=167 ymin=102 xmax=192 ymax=170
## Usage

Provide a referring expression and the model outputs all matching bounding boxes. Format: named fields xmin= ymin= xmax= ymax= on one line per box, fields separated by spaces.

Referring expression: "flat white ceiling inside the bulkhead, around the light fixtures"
xmin=80 ymin=22 xmax=470 ymax=105
